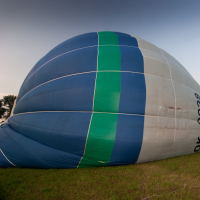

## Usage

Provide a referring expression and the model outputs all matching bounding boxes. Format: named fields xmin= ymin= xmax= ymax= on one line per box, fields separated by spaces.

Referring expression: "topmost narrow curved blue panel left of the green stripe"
xmin=21 ymin=32 xmax=98 ymax=86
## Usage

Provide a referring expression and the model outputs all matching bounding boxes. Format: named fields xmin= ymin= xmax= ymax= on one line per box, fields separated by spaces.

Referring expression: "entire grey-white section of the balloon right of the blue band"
xmin=136 ymin=37 xmax=200 ymax=163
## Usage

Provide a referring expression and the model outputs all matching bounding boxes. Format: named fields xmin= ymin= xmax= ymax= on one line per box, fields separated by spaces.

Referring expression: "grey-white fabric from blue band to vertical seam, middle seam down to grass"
xmin=137 ymin=74 xmax=175 ymax=163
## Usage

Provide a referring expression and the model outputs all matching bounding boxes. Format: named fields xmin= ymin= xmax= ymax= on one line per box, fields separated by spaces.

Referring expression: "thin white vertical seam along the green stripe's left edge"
xmin=77 ymin=32 xmax=99 ymax=168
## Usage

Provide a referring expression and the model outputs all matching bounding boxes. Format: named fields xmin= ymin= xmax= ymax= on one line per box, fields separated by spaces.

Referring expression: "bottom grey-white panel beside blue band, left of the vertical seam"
xmin=137 ymin=116 xmax=174 ymax=163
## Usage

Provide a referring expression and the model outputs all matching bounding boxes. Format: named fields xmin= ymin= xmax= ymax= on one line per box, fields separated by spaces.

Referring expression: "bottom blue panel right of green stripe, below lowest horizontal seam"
xmin=109 ymin=114 xmax=144 ymax=165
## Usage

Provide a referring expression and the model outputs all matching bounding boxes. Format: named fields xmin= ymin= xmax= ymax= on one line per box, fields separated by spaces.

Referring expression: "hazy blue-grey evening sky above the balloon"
xmin=0 ymin=0 xmax=200 ymax=98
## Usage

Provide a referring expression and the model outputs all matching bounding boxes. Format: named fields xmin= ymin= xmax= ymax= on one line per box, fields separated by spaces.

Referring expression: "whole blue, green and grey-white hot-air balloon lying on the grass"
xmin=0 ymin=32 xmax=200 ymax=168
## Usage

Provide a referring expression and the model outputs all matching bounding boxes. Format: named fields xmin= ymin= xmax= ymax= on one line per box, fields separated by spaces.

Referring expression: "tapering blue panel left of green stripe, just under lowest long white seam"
xmin=9 ymin=112 xmax=91 ymax=156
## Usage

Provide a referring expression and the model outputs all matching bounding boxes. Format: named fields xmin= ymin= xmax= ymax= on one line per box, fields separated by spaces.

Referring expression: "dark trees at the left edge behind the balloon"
xmin=0 ymin=95 xmax=16 ymax=119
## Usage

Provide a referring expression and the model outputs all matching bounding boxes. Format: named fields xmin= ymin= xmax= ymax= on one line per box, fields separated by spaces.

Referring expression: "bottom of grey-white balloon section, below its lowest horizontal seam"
xmin=137 ymin=116 xmax=199 ymax=163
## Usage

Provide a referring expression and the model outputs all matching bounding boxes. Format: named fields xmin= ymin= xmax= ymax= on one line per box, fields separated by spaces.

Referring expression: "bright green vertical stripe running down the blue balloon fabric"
xmin=79 ymin=32 xmax=121 ymax=167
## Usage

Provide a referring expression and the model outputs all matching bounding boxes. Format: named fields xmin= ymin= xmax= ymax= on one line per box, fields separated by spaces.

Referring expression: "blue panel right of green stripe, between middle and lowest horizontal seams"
xmin=119 ymin=72 xmax=146 ymax=115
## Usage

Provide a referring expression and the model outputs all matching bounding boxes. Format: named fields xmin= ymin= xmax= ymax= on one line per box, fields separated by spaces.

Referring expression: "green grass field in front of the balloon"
xmin=0 ymin=153 xmax=200 ymax=200
